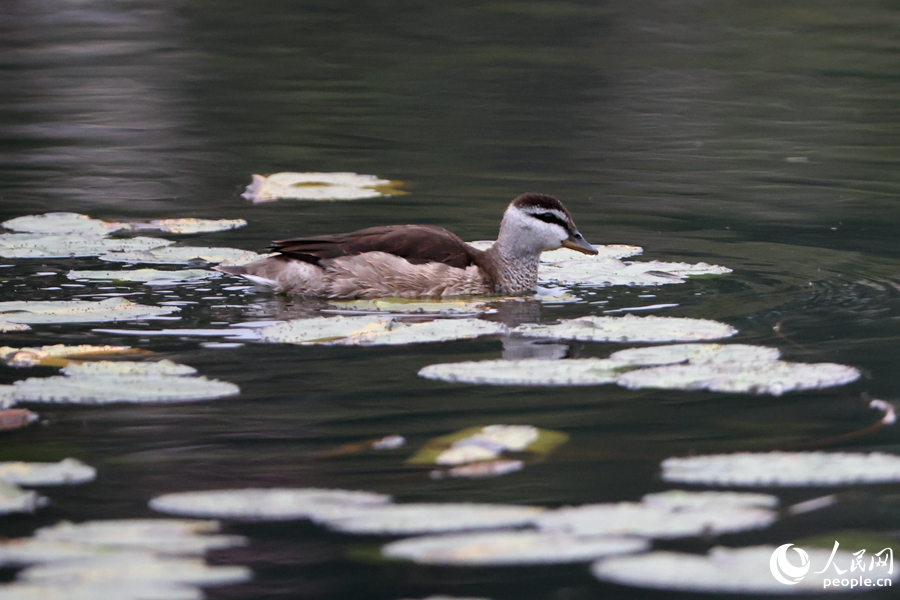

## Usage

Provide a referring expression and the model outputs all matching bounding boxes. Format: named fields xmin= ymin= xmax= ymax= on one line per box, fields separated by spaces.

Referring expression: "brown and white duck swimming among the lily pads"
xmin=215 ymin=193 xmax=597 ymax=300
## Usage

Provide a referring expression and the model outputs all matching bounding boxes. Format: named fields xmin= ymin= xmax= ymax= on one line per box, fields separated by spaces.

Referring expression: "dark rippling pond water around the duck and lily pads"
xmin=0 ymin=0 xmax=900 ymax=600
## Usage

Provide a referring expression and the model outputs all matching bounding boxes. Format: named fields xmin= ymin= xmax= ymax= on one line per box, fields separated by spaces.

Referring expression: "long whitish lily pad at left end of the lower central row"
xmin=150 ymin=488 xmax=391 ymax=521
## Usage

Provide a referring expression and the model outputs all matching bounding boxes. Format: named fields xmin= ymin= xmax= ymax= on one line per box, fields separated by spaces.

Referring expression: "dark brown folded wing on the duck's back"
xmin=270 ymin=225 xmax=482 ymax=269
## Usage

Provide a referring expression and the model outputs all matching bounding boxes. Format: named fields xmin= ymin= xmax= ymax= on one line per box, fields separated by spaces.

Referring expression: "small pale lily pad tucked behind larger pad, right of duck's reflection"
xmin=609 ymin=344 xmax=781 ymax=367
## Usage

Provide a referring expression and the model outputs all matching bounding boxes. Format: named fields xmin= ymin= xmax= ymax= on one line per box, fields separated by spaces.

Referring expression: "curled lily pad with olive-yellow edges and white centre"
xmin=406 ymin=425 xmax=569 ymax=465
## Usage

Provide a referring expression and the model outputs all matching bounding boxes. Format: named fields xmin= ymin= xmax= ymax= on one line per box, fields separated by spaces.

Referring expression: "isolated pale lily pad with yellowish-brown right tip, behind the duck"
xmin=241 ymin=173 xmax=403 ymax=203
